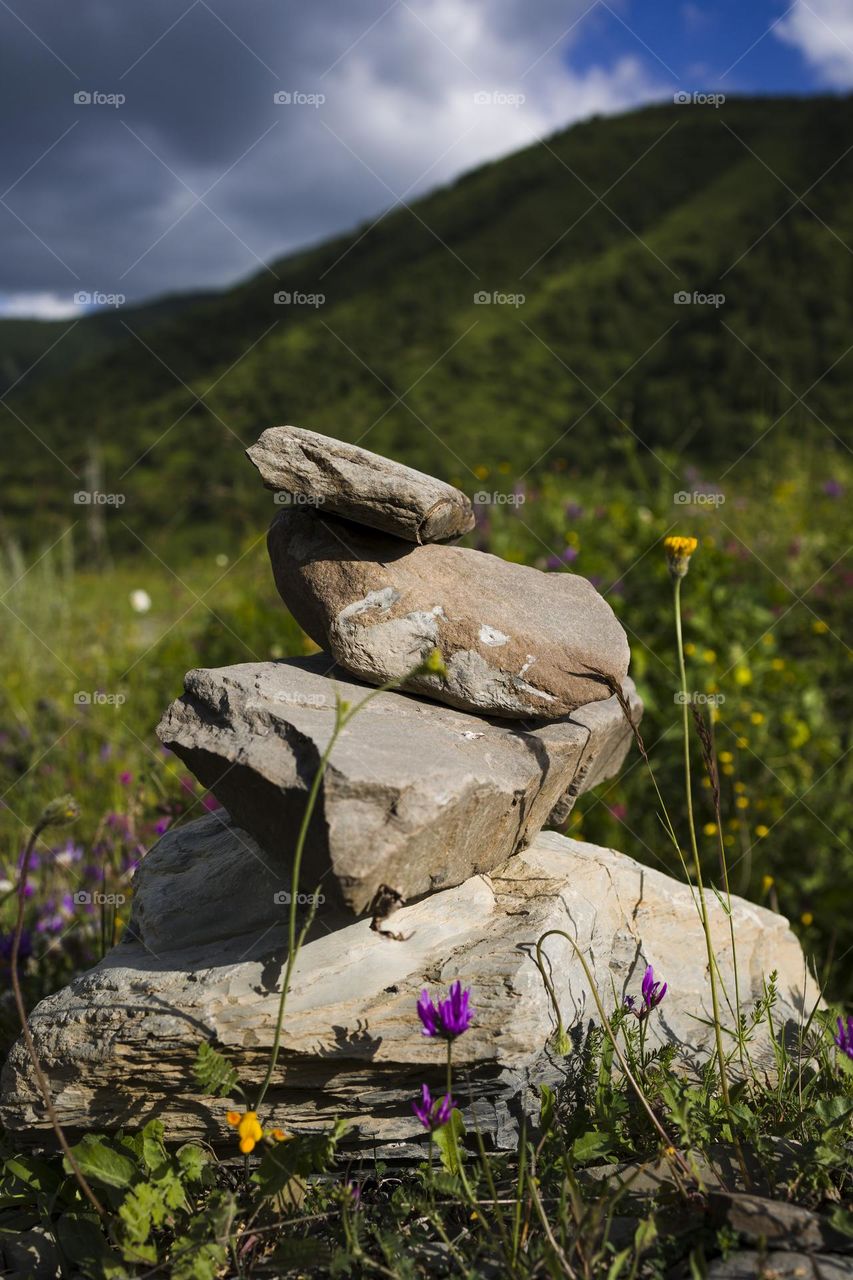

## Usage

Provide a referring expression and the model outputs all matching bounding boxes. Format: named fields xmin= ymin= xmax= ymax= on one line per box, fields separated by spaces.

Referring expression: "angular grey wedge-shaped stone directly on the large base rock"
xmin=158 ymin=654 xmax=640 ymax=913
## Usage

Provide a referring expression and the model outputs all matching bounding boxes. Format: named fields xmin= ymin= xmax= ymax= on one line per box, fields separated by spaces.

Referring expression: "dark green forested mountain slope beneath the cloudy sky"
xmin=0 ymin=97 xmax=853 ymax=543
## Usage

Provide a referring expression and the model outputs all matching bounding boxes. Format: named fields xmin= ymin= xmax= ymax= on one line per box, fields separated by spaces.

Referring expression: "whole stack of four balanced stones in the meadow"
xmin=0 ymin=426 xmax=811 ymax=1155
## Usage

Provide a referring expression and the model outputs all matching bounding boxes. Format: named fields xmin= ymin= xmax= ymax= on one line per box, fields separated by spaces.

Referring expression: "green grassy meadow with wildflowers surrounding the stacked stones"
xmin=0 ymin=460 xmax=853 ymax=1280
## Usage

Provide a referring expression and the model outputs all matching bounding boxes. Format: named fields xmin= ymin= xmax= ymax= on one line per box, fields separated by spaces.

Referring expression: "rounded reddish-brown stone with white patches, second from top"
xmin=268 ymin=509 xmax=630 ymax=719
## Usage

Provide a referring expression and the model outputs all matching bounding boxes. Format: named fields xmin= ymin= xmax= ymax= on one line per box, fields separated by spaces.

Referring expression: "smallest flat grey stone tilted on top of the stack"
xmin=246 ymin=426 xmax=474 ymax=543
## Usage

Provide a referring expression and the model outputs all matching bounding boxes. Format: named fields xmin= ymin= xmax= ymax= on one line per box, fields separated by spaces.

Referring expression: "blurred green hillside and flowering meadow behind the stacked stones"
xmin=0 ymin=99 xmax=853 ymax=1030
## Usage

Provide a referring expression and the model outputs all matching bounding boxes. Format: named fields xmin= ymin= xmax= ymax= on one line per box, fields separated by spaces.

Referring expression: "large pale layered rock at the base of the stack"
xmin=0 ymin=815 xmax=817 ymax=1155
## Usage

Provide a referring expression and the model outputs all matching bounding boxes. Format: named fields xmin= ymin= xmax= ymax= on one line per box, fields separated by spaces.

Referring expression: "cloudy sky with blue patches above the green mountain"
xmin=0 ymin=0 xmax=853 ymax=319
